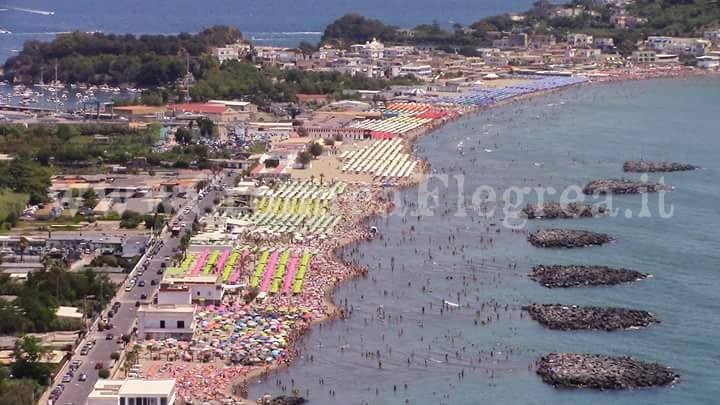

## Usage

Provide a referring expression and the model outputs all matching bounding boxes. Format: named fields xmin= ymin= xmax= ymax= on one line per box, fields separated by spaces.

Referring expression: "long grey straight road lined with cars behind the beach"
xmin=50 ymin=173 xmax=234 ymax=405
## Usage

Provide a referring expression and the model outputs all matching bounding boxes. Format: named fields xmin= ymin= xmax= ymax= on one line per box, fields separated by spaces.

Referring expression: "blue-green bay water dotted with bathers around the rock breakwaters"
xmin=251 ymin=78 xmax=720 ymax=405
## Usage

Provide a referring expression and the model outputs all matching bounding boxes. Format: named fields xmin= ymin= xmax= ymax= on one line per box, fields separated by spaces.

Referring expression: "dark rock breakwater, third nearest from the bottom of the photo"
xmin=530 ymin=265 xmax=648 ymax=288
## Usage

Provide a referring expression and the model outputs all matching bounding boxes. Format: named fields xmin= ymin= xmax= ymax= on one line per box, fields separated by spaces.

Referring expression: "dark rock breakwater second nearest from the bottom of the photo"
xmin=523 ymin=304 xmax=659 ymax=331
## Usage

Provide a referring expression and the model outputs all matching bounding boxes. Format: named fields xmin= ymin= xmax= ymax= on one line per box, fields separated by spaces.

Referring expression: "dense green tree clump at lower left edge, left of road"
xmin=0 ymin=259 xmax=116 ymax=334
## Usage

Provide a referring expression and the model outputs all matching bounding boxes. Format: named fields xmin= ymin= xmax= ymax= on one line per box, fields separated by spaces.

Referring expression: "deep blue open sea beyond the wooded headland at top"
xmin=0 ymin=0 xmax=532 ymax=61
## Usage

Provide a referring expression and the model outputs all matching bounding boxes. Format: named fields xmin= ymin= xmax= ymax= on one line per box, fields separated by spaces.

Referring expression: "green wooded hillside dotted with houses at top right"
xmin=322 ymin=0 xmax=720 ymax=54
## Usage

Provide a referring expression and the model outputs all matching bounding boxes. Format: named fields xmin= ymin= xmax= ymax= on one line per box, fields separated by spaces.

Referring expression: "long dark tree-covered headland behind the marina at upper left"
xmin=5 ymin=26 xmax=242 ymax=86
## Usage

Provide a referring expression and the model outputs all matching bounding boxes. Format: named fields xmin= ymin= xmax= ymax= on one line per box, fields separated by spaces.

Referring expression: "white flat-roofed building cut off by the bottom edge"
xmin=86 ymin=379 xmax=177 ymax=405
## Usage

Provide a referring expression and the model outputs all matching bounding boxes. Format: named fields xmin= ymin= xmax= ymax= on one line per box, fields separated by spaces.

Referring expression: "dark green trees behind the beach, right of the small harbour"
xmin=190 ymin=61 xmax=415 ymax=105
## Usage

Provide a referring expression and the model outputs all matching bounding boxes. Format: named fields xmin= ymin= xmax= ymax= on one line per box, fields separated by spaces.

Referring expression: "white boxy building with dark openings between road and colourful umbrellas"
xmin=138 ymin=304 xmax=195 ymax=340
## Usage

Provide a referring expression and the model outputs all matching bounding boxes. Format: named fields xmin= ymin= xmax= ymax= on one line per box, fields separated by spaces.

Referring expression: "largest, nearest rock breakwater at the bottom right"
xmin=537 ymin=353 xmax=679 ymax=390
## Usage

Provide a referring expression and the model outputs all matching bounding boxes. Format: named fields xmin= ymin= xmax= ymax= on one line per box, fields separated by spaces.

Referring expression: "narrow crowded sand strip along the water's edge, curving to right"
xmin=149 ymin=65 xmax=720 ymax=404
